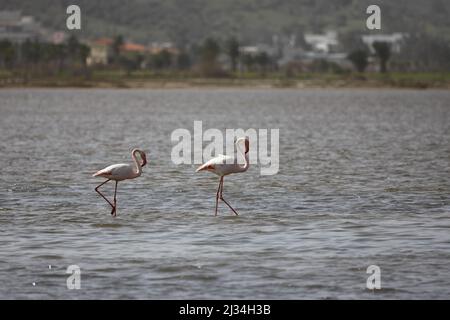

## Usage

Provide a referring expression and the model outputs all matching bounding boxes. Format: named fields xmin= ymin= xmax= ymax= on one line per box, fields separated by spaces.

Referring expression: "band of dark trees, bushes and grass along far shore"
xmin=0 ymin=36 xmax=450 ymax=88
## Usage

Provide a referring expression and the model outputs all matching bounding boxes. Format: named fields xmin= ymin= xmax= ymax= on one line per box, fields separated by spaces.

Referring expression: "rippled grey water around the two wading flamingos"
xmin=0 ymin=89 xmax=450 ymax=299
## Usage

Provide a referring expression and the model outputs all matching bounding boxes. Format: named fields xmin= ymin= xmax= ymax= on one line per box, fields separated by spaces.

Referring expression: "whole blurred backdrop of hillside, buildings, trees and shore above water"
xmin=0 ymin=0 xmax=450 ymax=87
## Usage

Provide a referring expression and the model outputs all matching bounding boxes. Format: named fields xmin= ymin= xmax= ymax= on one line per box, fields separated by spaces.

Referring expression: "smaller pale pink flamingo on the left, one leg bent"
xmin=92 ymin=149 xmax=147 ymax=217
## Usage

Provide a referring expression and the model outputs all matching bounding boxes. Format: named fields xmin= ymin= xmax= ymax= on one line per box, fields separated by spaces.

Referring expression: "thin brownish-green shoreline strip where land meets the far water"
xmin=0 ymin=77 xmax=450 ymax=90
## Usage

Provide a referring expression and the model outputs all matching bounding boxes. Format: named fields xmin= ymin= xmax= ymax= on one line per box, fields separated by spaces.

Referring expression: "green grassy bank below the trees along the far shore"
xmin=0 ymin=70 xmax=450 ymax=89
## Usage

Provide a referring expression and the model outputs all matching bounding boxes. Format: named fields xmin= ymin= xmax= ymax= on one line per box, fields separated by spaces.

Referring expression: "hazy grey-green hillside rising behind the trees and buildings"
xmin=0 ymin=0 xmax=450 ymax=45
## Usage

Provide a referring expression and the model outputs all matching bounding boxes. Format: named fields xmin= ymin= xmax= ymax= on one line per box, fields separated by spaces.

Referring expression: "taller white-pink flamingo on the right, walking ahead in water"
xmin=196 ymin=138 xmax=250 ymax=216
